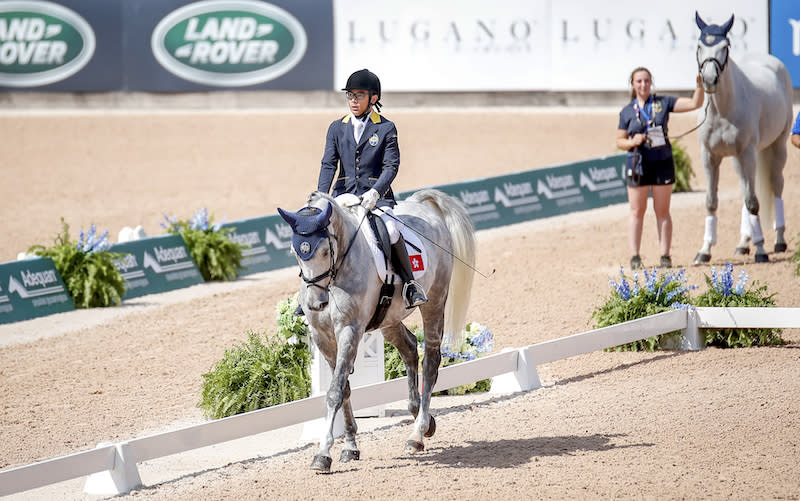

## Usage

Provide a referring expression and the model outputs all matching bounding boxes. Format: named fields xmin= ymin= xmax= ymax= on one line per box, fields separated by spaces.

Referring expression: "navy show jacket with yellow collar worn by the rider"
xmin=317 ymin=111 xmax=400 ymax=207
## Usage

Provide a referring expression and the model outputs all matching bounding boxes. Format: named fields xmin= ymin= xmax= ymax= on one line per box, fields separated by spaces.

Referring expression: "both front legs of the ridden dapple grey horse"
xmin=311 ymin=326 xmax=360 ymax=473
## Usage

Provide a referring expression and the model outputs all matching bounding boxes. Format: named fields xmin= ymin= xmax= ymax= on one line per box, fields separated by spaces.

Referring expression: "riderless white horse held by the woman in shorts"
xmin=694 ymin=13 xmax=792 ymax=264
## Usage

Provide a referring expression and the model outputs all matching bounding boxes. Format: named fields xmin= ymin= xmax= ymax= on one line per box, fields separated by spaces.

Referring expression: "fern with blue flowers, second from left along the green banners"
xmin=161 ymin=208 xmax=241 ymax=281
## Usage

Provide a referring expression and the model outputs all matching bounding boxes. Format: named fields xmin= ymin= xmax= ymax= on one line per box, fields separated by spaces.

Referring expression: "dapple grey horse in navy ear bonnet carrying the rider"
xmin=278 ymin=190 xmax=475 ymax=472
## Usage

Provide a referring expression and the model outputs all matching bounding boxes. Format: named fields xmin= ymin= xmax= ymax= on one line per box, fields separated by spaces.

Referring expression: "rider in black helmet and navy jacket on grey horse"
xmin=317 ymin=69 xmax=428 ymax=308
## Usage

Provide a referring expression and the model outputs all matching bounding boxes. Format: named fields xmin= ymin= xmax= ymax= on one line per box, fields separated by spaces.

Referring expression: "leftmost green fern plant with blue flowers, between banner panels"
xmin=28 ymin=218 xmax=125 ymax=308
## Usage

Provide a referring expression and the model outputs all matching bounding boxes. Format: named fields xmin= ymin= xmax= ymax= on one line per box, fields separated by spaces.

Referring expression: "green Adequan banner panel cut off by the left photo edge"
xmin=0 ymin=258 xmax=75 ymax=323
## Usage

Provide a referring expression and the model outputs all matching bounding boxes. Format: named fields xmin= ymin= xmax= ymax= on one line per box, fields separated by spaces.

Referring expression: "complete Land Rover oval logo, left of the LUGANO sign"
xmin=150 ymin=0 xmax=307 ymax=86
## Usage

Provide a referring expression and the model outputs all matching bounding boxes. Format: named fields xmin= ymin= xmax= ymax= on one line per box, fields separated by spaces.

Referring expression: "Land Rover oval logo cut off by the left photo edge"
xmin=0 ymin=0 xmax=95 ymax=87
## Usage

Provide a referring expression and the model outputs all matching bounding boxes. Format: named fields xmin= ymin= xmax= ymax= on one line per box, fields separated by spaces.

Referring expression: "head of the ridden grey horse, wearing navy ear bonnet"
xmin=278 ymin=198 xmax=335 ymax=311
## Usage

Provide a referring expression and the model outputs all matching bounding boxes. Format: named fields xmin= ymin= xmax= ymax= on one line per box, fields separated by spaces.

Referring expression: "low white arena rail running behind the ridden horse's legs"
xmin=0 ymin=308 xmax=800 ymax=496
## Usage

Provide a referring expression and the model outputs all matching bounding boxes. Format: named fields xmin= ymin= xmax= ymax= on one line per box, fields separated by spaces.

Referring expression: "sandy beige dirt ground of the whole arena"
xmin=0 ymin=101 xmax=800 ymax=500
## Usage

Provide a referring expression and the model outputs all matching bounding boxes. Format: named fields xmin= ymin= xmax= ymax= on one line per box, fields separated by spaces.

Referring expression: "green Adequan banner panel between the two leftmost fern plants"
xmin=109 ymin=235 xmax=203 ymax=301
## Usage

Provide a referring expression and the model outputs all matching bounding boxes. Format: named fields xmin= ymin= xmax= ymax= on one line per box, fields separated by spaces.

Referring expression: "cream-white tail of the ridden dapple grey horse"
xmin=408 ymin=189 xmax=475 ymax=349
